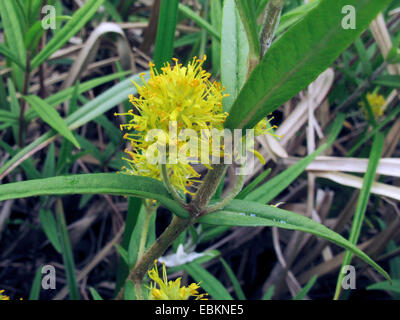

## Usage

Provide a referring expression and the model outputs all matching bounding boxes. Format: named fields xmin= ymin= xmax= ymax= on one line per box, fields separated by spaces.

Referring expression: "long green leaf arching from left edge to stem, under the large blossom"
xmin=0 ymin=173 xmax=189 ymax=218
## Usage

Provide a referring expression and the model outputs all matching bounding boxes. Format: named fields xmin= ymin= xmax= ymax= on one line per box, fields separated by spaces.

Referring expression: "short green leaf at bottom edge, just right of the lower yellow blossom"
xmin=182 ymin=262 xmax=233 ymax=300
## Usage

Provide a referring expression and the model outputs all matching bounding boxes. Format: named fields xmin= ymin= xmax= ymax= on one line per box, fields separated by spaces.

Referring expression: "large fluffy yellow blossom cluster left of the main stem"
xmin=115 ymin=56 xmax=276 ymax=193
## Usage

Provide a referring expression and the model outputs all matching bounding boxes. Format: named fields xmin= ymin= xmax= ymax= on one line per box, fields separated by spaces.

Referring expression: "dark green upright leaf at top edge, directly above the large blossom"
xmin=154 ymin=0 xmax=179 ymax=70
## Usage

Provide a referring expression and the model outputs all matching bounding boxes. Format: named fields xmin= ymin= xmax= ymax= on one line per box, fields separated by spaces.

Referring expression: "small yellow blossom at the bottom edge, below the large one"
xmin=148 ymin=260 xmax=207 ymax=300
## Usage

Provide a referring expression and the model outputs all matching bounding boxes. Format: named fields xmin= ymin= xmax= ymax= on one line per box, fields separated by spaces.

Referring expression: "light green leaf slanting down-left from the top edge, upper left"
xmin=30 ymin=0 xmax=104 ymax=69
